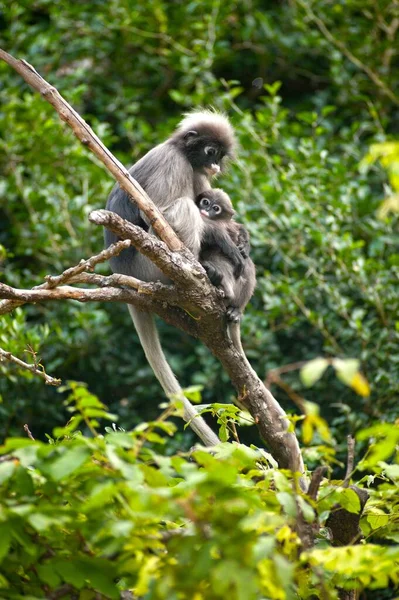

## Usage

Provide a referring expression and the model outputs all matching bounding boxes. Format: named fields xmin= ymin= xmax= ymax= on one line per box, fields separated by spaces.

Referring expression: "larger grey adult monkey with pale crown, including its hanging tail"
xmin=104 ymin=110 xmax=242 ymax=445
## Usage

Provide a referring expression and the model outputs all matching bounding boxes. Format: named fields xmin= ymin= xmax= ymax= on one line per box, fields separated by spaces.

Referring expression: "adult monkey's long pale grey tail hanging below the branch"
xmin=128 ymin=304 xmax=220 ymax=446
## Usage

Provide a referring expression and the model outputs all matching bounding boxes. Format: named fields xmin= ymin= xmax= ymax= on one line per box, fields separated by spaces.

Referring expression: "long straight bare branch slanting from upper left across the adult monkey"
xmin=0 ymin=48 xmax=183 ymax=251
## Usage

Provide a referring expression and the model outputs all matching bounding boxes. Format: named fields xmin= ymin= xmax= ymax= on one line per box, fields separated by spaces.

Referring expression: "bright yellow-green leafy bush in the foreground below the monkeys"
xmin=0 ymin=390 xmax=399 ymax=600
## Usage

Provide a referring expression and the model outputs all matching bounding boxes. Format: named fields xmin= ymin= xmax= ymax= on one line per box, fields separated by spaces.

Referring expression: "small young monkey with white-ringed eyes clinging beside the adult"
xmin=195 ymin=189 xmax=256 ymax=357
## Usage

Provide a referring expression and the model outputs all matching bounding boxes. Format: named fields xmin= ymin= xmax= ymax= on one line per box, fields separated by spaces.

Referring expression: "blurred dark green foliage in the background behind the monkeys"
xmin=0 ymin=0 xmax=399 ymax=460
